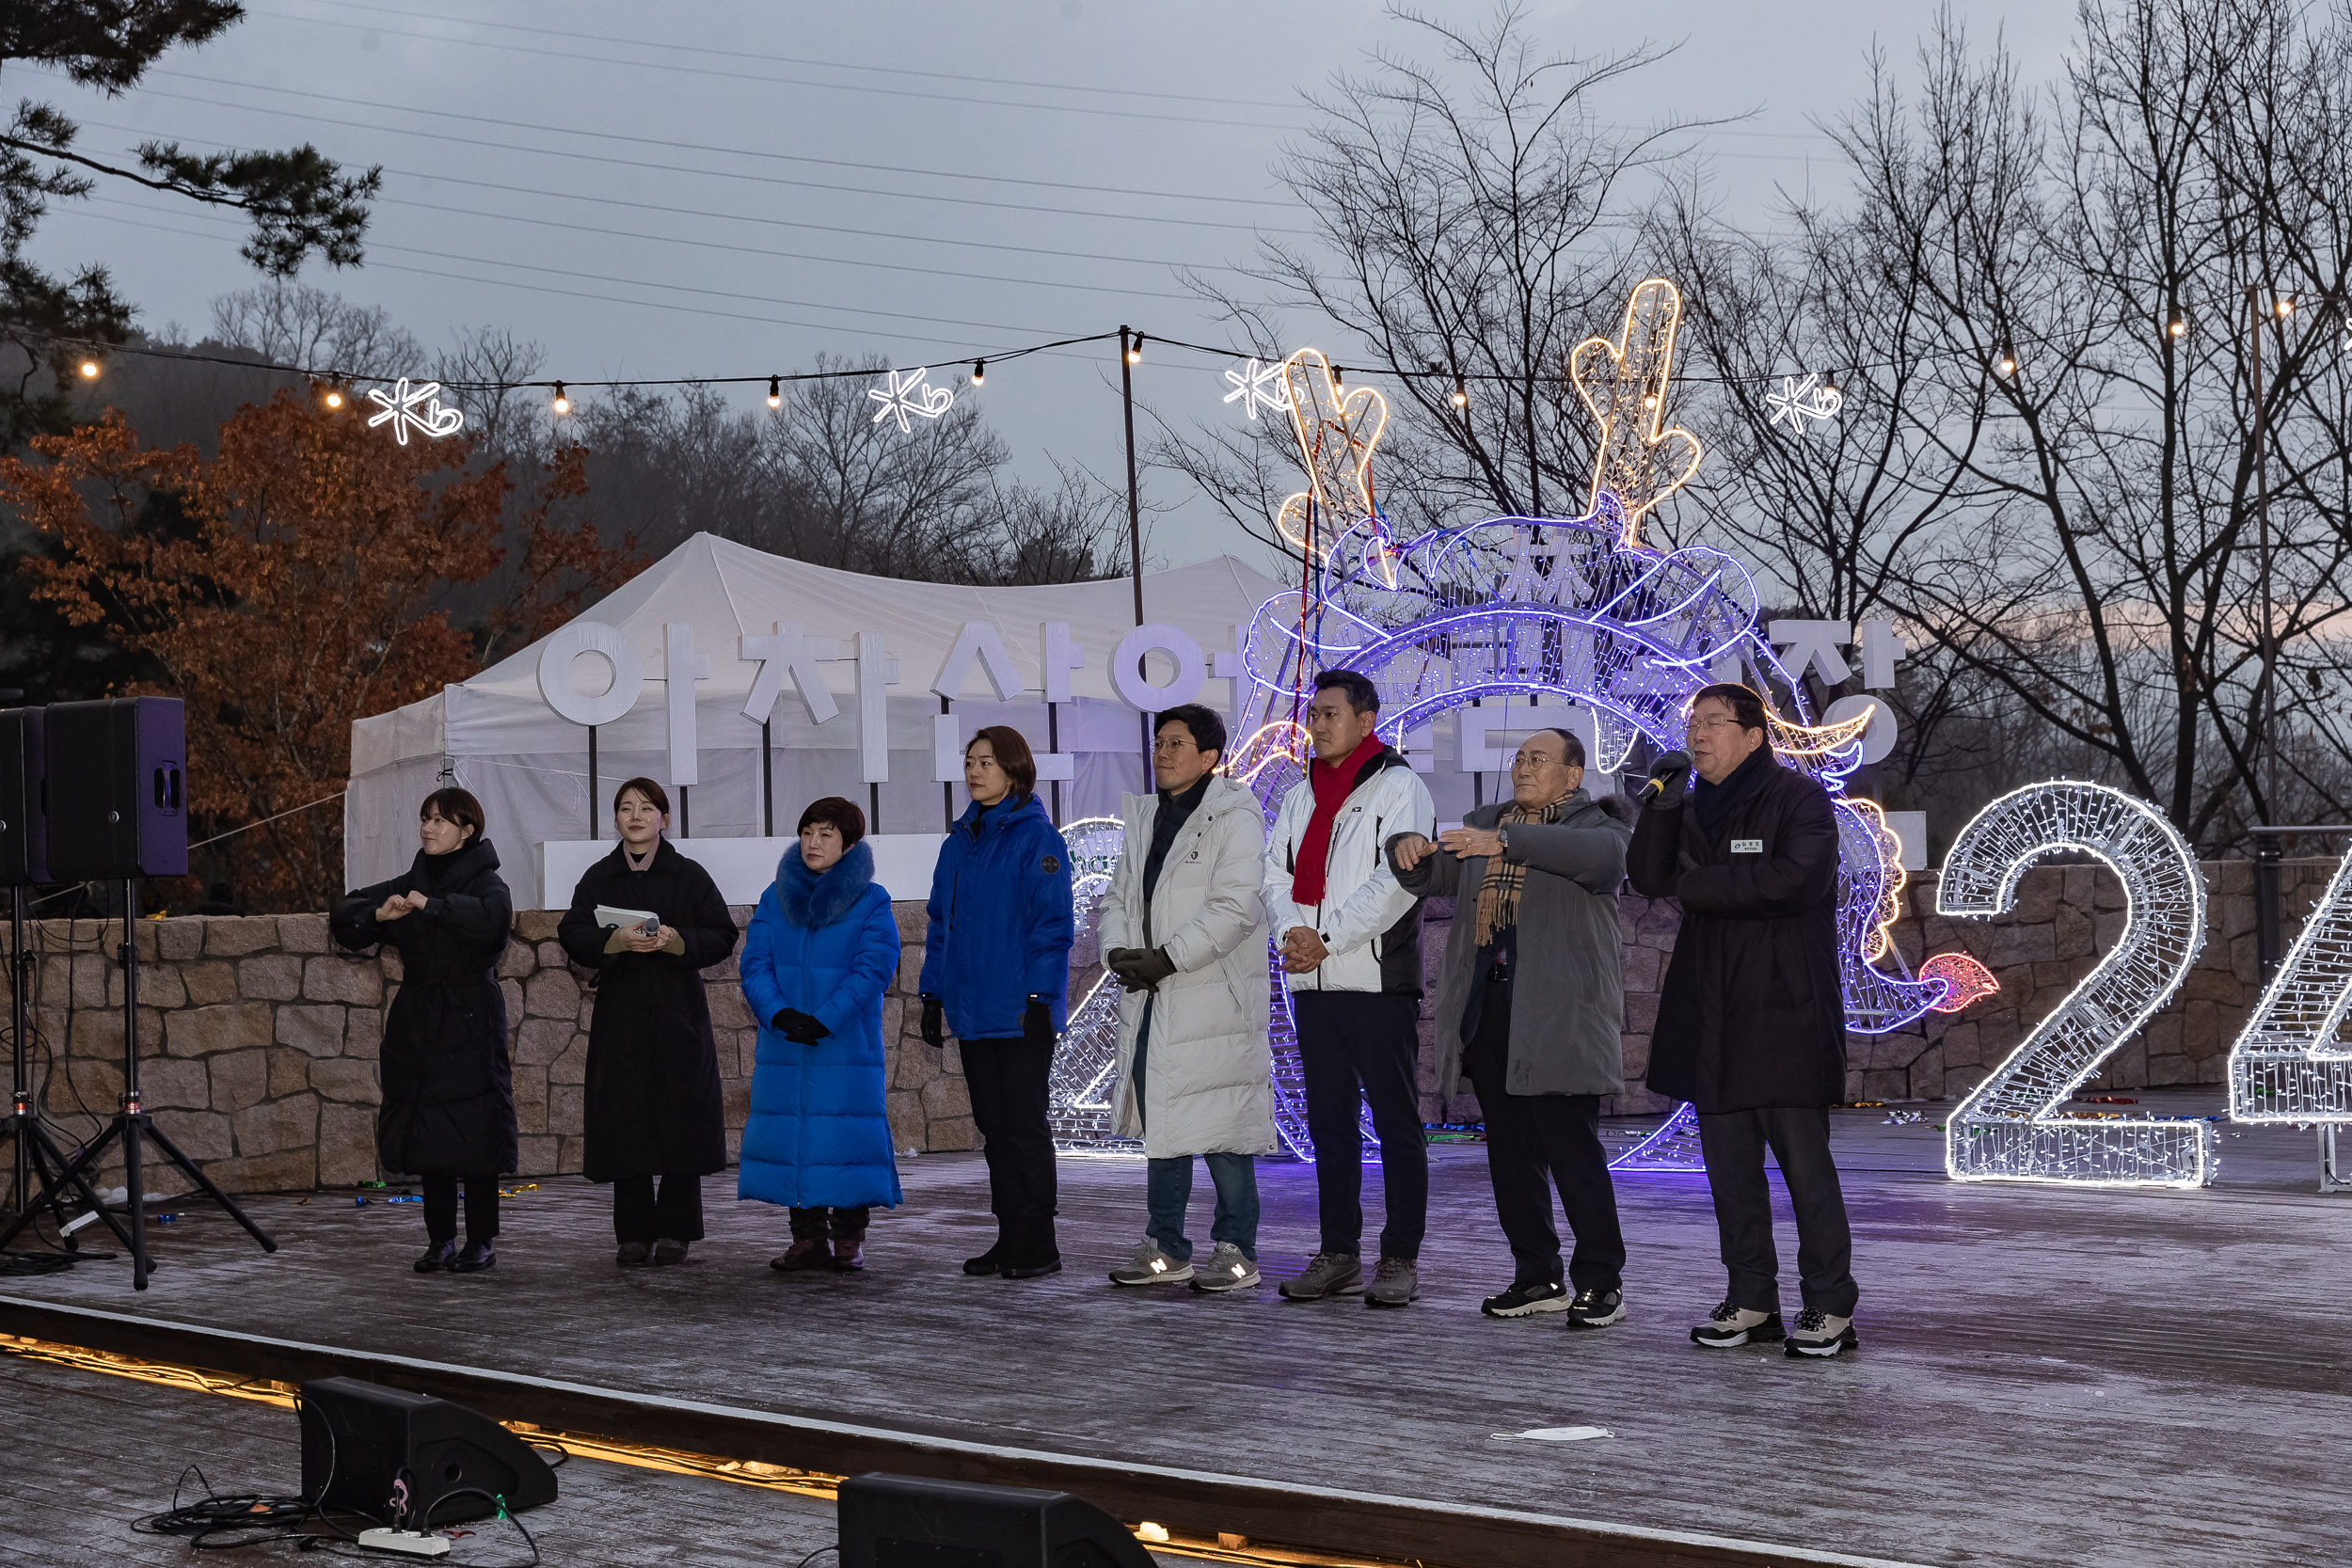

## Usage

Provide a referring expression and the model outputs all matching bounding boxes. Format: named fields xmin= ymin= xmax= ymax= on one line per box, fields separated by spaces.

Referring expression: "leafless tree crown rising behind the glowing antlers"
xmin=1155 ymin=2 xmax=1693 ymax=538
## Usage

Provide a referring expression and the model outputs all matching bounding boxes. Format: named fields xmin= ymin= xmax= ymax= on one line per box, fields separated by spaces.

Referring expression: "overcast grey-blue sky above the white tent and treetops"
xmin=27 ymin=0 xmax=2073 ymax=576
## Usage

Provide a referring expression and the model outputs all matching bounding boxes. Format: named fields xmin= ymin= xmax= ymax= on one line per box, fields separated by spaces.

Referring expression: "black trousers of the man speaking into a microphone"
xmin=1698 ymin=1107 xmax=1858 ymax=1317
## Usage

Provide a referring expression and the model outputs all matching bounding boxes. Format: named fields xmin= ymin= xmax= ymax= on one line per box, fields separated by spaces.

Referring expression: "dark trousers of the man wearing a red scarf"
xmin=1292 ymin=992 xmax=1430 ymax=1262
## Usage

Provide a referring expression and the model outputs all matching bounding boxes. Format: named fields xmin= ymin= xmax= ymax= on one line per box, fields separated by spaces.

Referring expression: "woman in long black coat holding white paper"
xmin=555 ymin=778 xmax=737 ymax=1267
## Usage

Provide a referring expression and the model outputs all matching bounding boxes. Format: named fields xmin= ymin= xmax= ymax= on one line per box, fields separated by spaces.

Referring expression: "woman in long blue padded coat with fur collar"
xmin=737 ymin=795 xmax=898 ymax=1275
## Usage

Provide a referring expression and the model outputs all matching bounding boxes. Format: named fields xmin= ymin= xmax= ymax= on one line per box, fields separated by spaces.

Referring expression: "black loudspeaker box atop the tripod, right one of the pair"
xmin=42 ymin=696 xmax=188 ymax=881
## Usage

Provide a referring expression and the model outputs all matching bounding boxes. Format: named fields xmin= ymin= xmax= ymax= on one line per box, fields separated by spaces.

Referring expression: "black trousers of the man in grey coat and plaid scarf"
xmin=1463 ymin=980 xmax=1626 ymax=1293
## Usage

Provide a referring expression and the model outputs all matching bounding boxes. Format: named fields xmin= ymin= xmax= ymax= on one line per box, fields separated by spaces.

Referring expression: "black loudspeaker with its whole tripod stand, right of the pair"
xmin=0 ymin=696 xmax=278 ymax=1291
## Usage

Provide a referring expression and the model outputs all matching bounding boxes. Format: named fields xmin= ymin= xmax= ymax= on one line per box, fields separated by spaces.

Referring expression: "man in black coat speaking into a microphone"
xmin=1626 ymin=684 xmax=1856 ymax=1356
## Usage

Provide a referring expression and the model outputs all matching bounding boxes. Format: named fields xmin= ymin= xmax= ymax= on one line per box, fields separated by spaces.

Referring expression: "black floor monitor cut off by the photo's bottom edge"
xmin=837 ymin=1474 xmax=1152 ymax=1568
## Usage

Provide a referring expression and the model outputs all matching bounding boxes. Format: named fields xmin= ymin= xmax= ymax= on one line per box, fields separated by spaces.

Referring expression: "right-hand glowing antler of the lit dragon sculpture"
xmin=1569 ymin=277 xmax=1701 ymax=546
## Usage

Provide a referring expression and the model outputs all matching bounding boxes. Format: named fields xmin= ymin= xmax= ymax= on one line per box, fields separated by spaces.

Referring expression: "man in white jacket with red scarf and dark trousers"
xmin=1263 ymin=670 xmax=1438 ymax=1307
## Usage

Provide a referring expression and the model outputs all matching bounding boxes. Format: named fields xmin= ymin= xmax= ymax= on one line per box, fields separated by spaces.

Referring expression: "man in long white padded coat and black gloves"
xmin=1104 ymin=703 xmax=1275 ymax=1291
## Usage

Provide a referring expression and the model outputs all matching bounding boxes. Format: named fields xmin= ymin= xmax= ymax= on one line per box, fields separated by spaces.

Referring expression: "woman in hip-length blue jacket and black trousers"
xmin=922 ymin=724 xmax=1075 ymax=1279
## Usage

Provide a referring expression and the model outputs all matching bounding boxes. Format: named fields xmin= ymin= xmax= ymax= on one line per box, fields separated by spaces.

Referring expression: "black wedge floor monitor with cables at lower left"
xmin=301 ymin=1378 xmax=555 ymax=1530
